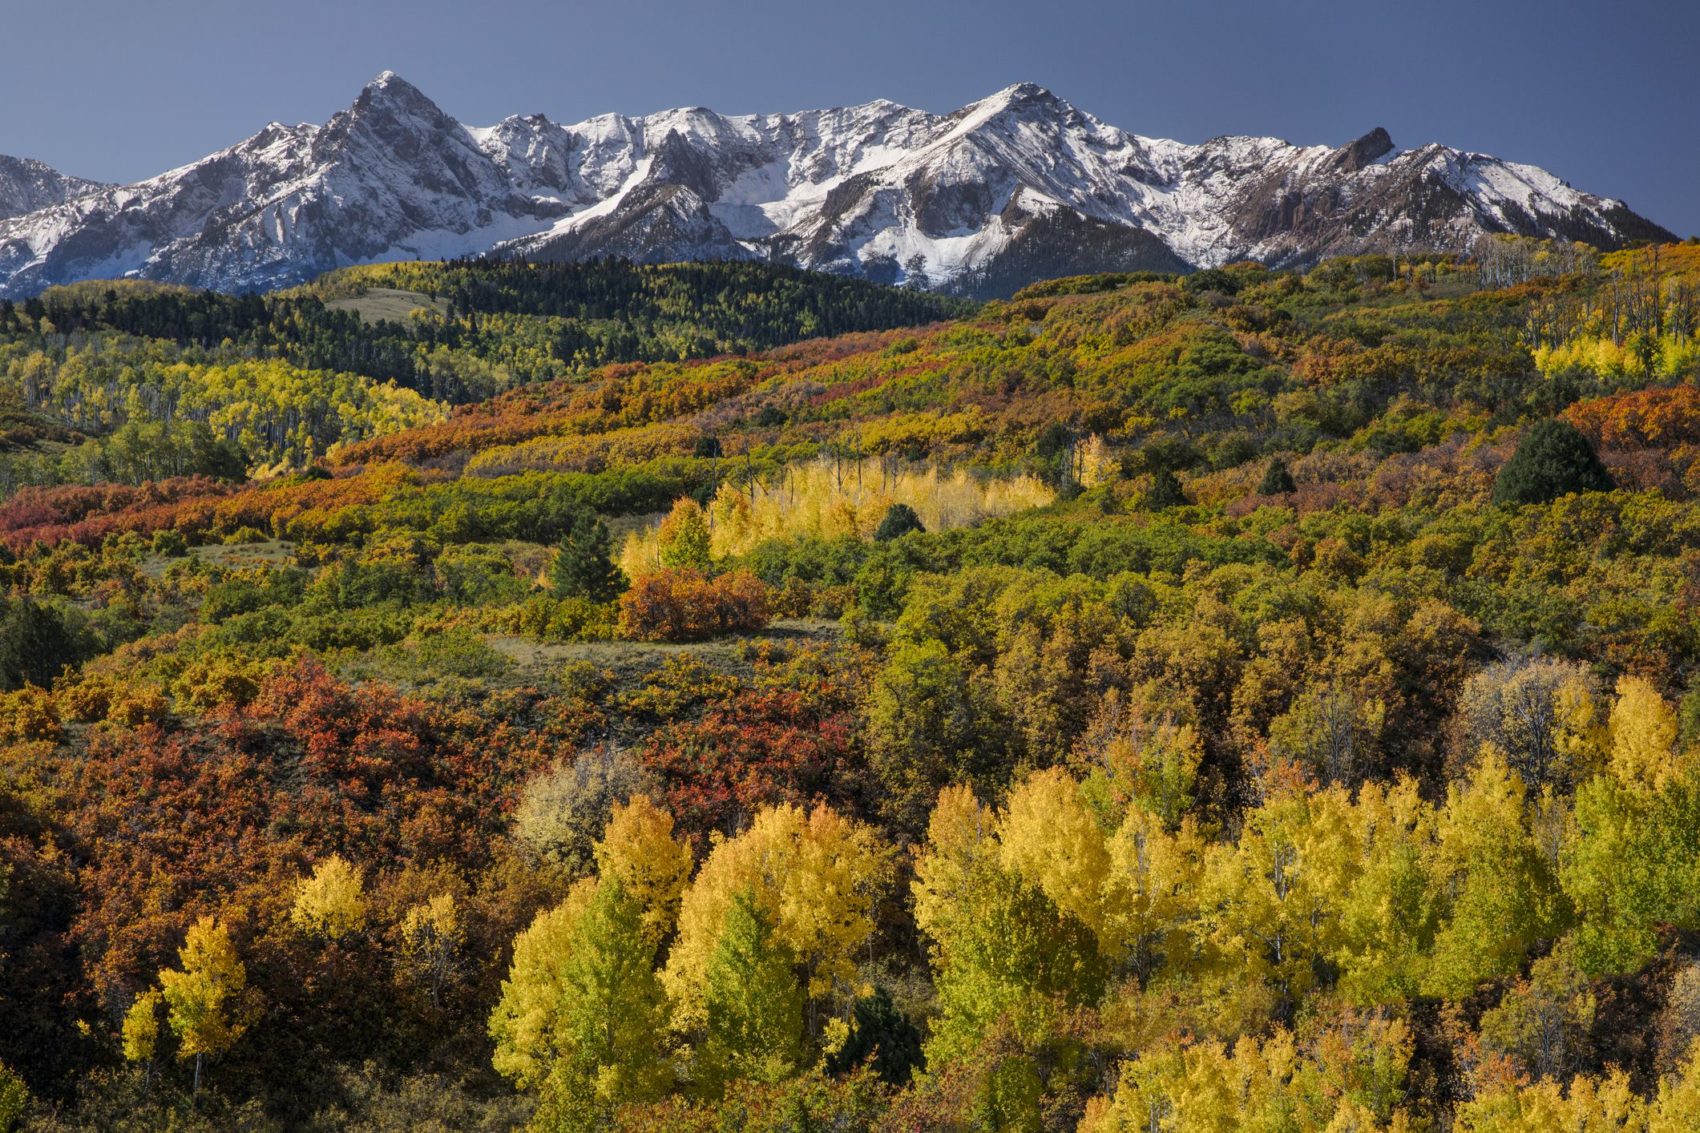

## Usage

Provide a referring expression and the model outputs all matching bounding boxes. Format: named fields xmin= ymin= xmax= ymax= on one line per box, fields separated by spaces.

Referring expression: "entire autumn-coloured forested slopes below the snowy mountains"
xmin=0 ymin=238 xmax=1700 ymax=1133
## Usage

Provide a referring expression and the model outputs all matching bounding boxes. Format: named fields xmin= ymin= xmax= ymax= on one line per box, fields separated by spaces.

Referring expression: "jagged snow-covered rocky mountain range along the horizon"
xmin=0 ymin=71 xmax=1671 ymax=296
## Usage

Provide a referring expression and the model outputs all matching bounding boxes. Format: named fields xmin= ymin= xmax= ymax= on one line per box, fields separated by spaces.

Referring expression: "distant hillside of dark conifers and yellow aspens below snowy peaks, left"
xmin=0 ymin=260 xmax=971 ymax=493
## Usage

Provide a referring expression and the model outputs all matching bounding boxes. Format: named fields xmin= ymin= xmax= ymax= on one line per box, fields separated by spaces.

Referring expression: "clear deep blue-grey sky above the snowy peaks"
xmin=0 ymin=0 xmax=1700 ymax=236
